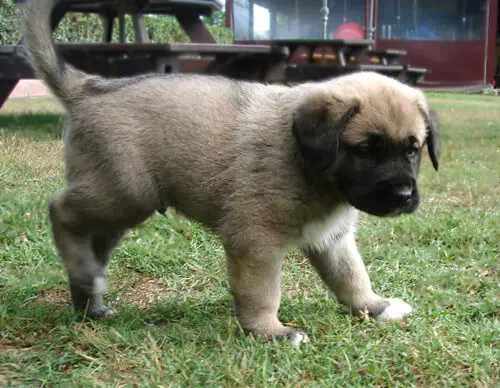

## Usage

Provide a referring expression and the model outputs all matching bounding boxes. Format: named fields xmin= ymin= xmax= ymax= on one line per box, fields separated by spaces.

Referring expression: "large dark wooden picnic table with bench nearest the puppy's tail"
xmin=0 ymin=0 xmax=289 ymax=107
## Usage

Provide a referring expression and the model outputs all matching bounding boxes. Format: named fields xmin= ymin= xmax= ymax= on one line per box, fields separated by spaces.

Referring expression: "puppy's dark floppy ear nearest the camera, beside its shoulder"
xmin=292 ymin=99 xmax=359 ymax=171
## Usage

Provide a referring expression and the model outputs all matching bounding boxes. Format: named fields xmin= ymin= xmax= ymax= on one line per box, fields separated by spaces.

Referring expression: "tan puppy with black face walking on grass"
xmin=25 ymin=0 xmax=439 ymax=345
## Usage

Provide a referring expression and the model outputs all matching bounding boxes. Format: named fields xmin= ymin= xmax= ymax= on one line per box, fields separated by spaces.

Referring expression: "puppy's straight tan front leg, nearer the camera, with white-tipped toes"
xmin=227 ymin=236 xmax=308 ymax=346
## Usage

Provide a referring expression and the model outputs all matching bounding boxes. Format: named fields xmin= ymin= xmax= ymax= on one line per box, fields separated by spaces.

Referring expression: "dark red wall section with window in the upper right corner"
xmin=375 ymin=0 xmax=498 ymax=86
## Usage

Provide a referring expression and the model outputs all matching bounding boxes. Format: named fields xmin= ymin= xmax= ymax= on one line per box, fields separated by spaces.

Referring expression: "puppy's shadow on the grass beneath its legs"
xmin=5 ymin=286 xmax=344 ymax=335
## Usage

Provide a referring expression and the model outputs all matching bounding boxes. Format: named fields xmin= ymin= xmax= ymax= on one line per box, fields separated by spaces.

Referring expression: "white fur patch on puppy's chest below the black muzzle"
xmin=300 ymin=205 xmax=358 ymax=249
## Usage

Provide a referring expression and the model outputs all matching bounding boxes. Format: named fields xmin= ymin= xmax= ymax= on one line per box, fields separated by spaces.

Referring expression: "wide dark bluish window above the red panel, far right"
xmin=377 ymin=0 xmax=487 ymax=40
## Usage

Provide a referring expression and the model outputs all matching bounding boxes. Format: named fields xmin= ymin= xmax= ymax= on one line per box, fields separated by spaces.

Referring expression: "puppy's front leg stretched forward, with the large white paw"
xmin=305 ymin=232 xmax=412 ymax=320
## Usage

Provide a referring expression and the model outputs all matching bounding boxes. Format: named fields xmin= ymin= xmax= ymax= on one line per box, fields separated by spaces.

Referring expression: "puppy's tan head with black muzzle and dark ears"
xmin=293 ymin=73 xmax=440 ymax=216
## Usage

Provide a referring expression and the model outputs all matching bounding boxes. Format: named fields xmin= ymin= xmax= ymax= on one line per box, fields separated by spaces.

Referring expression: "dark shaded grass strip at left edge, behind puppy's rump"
xmin=0 ymin=113 xmax=64 ymax=140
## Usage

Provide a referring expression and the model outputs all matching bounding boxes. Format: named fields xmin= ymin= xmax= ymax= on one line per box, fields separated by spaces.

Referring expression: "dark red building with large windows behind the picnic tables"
xmin=226 ymin=0 xmax=500 ymax=86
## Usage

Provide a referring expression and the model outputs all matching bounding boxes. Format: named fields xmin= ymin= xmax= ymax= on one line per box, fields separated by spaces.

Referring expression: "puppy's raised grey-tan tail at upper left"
xmin=24 ymin=0 xmax=86 ymax=105
